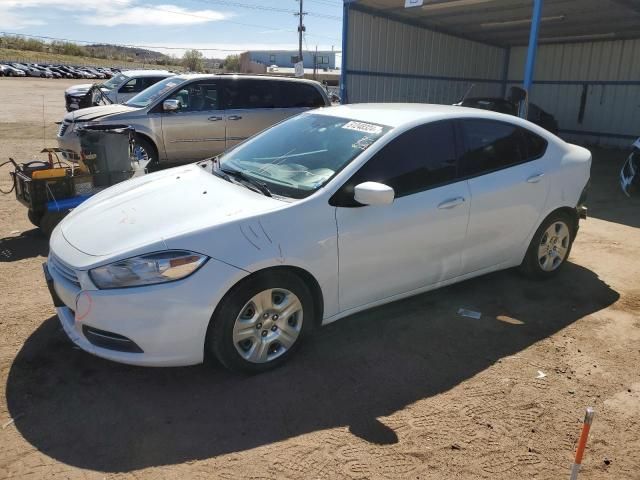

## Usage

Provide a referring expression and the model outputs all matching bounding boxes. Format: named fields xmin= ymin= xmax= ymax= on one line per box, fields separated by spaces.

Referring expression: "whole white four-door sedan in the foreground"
xmin=45 ymin=104 xmax=591 ymax=372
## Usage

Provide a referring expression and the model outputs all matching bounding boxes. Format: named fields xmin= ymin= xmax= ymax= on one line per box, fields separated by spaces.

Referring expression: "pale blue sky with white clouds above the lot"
xmin=0 ymin=0 xmax=342 ymax=58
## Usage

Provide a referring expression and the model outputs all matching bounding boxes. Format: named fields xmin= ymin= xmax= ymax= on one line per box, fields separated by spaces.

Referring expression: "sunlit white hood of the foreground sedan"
xmin=59 ymin=164 xmax=287 ymax=256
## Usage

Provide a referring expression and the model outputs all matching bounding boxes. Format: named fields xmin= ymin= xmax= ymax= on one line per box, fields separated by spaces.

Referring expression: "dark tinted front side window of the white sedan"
xmin=339 ymin=121 xmax=457 ymax=205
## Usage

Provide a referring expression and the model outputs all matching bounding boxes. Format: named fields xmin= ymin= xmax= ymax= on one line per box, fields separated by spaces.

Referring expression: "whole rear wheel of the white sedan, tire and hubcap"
xmin=520 ymin=212 xmax=576 ymax=278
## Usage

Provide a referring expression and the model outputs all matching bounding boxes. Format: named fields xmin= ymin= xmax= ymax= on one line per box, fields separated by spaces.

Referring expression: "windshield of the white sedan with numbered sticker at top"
xmin=220 ymin=114 xmax=390 ymax=198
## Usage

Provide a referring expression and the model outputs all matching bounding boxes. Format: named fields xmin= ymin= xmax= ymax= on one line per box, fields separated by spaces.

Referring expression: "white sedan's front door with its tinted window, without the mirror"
xmin=335 ymin=121 xmax=469 ymax=311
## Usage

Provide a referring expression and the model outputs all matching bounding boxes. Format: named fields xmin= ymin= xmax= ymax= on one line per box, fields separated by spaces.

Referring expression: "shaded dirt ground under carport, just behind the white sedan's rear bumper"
xmin=587 ymin=147 xmax=640 ymax=228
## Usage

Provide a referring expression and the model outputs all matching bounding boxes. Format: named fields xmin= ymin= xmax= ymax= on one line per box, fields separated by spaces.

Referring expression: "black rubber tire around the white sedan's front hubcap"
xmin=205 ymin=270 xmax=316 ymax=373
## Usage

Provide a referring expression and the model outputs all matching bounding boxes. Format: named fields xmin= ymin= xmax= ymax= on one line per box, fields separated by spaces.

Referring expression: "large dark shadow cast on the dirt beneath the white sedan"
xmin=7 ymin=264 xmax=619 ymax=472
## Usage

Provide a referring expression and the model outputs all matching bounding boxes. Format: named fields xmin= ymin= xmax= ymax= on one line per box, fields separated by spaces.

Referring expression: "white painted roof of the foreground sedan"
xmin=313 ymin=103 xmax=540 ymax=132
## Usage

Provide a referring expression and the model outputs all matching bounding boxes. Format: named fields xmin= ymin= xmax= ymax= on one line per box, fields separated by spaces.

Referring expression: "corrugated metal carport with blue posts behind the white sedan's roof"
xmin=341 ymin=0 xmax=640 ymax=146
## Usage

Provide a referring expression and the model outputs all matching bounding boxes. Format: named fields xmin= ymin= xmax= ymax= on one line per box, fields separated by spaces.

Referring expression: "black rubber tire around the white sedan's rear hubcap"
xmin=520 ymin=212 xmax=578 ymax=279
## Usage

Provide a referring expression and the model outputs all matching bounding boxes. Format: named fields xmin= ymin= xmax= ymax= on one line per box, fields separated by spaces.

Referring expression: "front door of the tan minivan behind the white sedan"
xmin=162 ymin=80 xmax=226 ymax=163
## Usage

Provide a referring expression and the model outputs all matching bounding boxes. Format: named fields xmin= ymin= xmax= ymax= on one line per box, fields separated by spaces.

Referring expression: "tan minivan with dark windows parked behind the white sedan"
xmin=58 ymin=75 xmax=330 ymax=166
